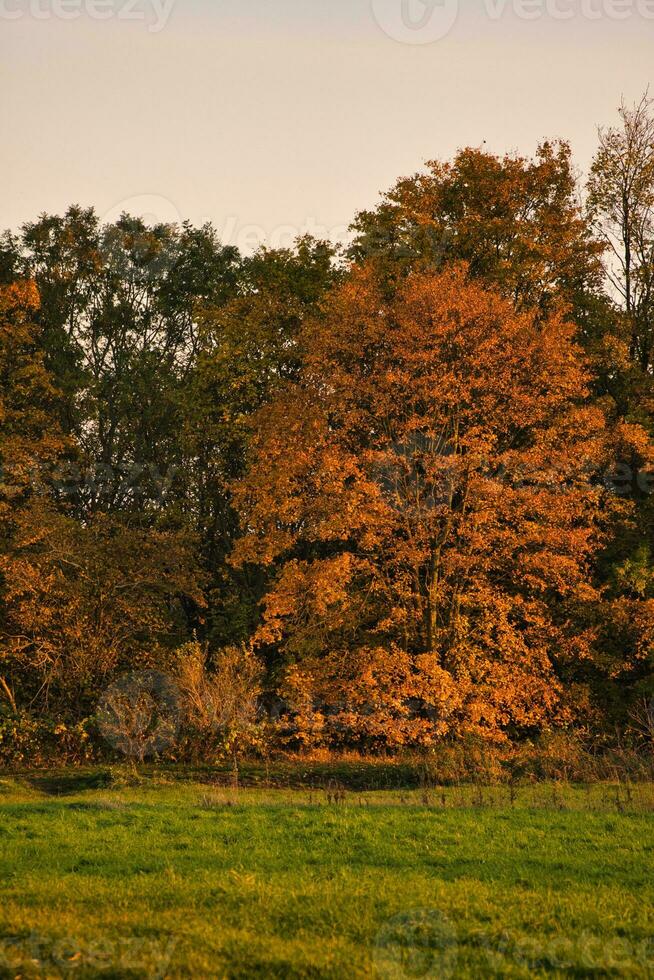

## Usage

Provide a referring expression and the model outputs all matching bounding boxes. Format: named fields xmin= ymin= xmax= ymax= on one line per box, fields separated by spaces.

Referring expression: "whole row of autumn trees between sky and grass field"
xmin=0 ymin=98 xmax=654 ymax=762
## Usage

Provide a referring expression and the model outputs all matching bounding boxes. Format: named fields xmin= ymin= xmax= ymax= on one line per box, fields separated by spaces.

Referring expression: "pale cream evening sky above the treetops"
xmin=0 ymin=0 xmax=654 ymax=251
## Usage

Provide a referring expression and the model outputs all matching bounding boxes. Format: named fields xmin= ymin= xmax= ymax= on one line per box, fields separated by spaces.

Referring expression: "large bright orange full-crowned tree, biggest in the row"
xmin=236 ymin=267 xmax=606 ymax=742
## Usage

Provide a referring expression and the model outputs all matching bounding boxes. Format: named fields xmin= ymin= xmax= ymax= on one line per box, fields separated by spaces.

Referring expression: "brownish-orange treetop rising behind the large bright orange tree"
xmin=351 ymin=142 xmax=601 ymax=323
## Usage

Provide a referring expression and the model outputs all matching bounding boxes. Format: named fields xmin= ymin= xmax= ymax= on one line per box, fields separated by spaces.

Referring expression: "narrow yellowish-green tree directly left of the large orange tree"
xmin=178 ymin=236 xmax=338 ymax=647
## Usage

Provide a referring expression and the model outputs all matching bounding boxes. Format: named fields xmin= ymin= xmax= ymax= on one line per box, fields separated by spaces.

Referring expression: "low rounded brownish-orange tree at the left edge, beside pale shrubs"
xmin=0 ymin=500 xmax=204 ymax=717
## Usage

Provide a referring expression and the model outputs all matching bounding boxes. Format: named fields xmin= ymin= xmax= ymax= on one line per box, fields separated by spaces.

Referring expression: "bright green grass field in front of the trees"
xmin=0 ymin=776 xmax=654 ymax=980
